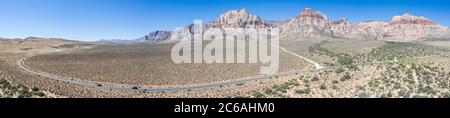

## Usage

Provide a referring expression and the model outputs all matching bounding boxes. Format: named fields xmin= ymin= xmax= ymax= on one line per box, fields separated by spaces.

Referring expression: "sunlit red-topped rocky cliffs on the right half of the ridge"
xmin=281 ymin=8 xmax=450 ymax=41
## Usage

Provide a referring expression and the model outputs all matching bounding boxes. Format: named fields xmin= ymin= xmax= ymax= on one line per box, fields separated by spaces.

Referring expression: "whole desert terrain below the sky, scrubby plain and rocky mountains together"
xmin=0 ymin=8 xmax=450 ymax=98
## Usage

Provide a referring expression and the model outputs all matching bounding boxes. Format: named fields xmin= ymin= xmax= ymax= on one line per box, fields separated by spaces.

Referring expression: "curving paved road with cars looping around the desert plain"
xmin=16 ymin=46 xmax=327 ymax=92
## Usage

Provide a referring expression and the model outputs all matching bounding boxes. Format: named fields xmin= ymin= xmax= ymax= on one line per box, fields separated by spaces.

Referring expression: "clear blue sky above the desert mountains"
xmin=0 ymin=0 xmax=450 ymax=41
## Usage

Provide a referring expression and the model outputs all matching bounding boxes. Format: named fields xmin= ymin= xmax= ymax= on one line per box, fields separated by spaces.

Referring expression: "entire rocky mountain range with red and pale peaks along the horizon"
xmin=103 ymin=8 xmax=450 ymax=43
